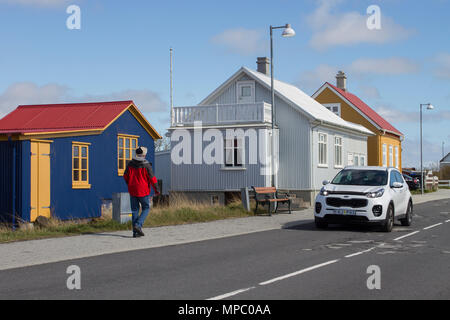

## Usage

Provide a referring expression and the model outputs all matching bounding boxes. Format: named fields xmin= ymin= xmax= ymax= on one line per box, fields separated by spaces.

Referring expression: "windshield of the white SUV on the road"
xmin=331 ymin=169 xmax=388 ymax=186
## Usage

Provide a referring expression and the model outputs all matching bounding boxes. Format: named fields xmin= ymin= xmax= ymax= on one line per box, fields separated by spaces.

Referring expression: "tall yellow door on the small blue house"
xmin=30 ymin=141 xmax=51 ymax=222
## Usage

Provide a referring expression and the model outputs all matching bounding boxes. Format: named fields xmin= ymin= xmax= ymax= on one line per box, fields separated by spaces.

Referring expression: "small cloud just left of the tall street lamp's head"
xmin=211 ymin=28 xmax=266 ymax=55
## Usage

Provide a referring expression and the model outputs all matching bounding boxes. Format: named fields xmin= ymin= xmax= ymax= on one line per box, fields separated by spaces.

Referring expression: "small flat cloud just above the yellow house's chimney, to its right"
xmin=349 ymin=57 xmax=420 ymax=75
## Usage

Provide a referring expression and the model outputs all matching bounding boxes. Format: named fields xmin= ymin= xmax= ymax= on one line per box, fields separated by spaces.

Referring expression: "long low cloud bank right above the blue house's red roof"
xmin=0 ymin=82 xmax=168 ymax=118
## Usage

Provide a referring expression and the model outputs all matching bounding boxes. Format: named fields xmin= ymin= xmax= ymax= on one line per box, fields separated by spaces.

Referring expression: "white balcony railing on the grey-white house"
xmin=172 ymin=102 xmax=272 ymax=126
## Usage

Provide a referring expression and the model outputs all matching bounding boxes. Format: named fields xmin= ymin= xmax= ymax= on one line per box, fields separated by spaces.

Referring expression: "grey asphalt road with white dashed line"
xmin=0 ymin=200 xmax=450 ymax=300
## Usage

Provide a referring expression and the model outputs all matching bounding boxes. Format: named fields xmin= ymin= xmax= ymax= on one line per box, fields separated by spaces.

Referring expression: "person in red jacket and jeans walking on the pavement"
xmin=123 ymin=147 xmax=159 ymax=238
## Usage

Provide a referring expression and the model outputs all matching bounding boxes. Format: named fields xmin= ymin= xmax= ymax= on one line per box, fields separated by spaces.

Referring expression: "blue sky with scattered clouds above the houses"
xmin=0 ymin=0 xmax=450 ymax=165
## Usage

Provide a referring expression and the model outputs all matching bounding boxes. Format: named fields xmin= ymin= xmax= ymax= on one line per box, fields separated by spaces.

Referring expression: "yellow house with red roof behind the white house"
xmin=313 ymin=71 xmax=404 ymax=170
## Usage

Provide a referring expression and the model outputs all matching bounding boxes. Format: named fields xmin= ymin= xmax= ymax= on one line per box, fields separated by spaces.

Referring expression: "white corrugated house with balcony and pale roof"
xmin=164 ymin=59 xmax=373 ymax=205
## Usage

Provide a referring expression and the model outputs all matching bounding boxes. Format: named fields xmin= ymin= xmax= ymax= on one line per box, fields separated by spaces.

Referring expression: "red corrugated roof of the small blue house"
xmin=0 ymin=100 xmax=134 ymax=134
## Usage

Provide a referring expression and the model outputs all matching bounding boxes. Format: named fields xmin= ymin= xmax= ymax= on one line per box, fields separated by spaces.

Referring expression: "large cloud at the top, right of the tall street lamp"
xmin=307 ymin=0 xmax=412 ymax=50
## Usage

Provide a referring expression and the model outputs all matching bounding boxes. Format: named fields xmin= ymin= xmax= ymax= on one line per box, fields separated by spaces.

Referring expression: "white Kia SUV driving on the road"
xmin=314 ymin=167 xmax=413 ymax=232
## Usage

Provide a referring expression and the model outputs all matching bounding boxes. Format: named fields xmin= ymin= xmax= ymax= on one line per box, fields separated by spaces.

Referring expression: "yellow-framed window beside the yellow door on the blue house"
xmin=72 ymin=142 xmax=91 ymax=189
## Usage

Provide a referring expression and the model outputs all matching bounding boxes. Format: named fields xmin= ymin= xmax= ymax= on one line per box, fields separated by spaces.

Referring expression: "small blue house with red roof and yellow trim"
xmin=0 ymin=101 xmax=161 ymax=222
